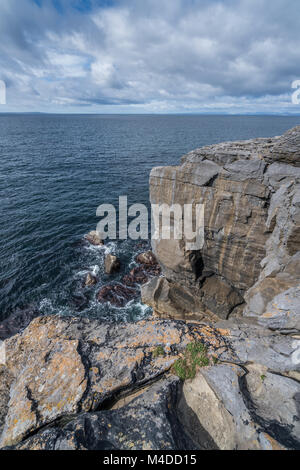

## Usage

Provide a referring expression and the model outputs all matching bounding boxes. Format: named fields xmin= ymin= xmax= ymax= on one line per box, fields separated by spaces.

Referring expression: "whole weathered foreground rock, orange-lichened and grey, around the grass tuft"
xmin=0 ymin=316 xmax=300 ymax=449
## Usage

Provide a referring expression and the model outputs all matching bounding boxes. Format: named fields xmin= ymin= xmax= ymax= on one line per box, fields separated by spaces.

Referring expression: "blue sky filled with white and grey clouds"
xmin=0 ymin=0 xmax=300 ymax=114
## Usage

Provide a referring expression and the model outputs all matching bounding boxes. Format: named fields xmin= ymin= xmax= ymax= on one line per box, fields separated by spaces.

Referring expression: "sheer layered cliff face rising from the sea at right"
xmin=143 ymin=126 xmax=300 ymax=331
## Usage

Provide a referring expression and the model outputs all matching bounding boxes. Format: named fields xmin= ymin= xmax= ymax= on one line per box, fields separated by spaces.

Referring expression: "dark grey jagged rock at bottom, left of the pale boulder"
xmin=11 ymin=377 xmax=196 ymax=450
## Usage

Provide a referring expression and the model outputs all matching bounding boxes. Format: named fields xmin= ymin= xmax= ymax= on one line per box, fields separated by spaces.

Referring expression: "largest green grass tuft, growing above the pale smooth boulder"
xmin=173 ymin=342 xmax=210 ymax=381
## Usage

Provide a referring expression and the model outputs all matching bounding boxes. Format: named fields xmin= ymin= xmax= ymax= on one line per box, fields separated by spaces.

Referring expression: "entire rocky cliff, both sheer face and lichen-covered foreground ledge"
xmin=0 ymin=127 xmax=300 ymax=450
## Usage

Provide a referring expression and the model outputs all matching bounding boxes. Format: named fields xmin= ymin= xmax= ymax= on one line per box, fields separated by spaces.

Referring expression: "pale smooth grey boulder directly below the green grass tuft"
xmin=178 ymin=364 xmax=290 ymax=450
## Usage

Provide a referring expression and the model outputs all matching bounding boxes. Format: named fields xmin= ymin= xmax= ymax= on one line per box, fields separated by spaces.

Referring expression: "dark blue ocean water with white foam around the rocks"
xmin=0 ymin=114 xmax=300 ymax=321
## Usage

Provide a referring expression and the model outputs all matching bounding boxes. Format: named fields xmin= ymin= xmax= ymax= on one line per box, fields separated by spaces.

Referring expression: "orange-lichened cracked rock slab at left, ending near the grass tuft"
xmin=0 ymin=316 xmax=200 ymax=447
